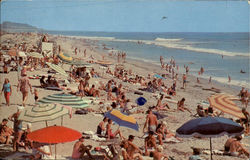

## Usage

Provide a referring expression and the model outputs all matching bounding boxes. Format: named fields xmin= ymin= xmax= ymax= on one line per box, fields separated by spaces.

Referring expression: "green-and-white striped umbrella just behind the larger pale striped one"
xmin=38 ymin=93 xmax=91 ymax=108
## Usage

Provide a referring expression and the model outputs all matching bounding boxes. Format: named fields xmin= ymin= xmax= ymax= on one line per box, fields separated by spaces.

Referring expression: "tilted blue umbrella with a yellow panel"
xmin=104 ymin=109 xmax=139 ymax=131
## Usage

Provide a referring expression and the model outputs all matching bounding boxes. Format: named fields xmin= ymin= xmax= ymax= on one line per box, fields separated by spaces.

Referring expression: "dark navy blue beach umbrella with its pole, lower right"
xmin=176 ymin=117 xmax=244 ymax=159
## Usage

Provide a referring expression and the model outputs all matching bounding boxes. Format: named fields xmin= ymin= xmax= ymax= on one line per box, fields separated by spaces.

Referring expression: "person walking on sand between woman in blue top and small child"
xmin=17 ymin=73 xmax=32 ymax=107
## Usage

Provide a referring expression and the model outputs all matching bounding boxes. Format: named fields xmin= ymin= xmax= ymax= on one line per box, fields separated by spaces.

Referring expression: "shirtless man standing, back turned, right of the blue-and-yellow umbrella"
xmin=143 ymin=109 xmax=158 ymax=132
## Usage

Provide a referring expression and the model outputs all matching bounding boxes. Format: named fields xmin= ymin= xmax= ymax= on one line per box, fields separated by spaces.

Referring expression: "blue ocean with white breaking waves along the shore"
xmin=47 ymin=32 xmax=250 ymax=88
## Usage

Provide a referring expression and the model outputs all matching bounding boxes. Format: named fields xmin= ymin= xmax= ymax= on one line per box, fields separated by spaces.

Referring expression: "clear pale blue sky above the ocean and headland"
xmin=1 ymin=0 xmax=250 ymax=32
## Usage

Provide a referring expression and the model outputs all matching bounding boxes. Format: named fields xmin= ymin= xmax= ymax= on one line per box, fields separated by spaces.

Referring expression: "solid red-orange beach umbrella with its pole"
xmin=27 ymin=126 xmax=82 ymax=159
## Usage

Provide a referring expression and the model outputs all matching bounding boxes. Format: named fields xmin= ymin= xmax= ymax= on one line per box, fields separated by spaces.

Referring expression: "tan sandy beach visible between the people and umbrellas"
xmin=0 ymin=33 xmax=250 ymax=160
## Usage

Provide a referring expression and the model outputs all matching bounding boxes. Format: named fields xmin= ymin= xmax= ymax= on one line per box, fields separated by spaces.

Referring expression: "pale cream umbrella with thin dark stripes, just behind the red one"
xmin=18 ymin=104 xmax=69 ymax=126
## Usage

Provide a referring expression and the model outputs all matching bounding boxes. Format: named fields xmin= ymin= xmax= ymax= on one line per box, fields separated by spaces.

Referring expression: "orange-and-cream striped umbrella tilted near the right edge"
xmin=208 ymin=94 xmax=245 ymax=118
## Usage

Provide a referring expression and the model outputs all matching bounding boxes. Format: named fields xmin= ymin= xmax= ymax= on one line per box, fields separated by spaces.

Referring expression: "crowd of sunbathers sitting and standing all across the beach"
xmin=0 ymin=32 xmax=250 ymax=160
